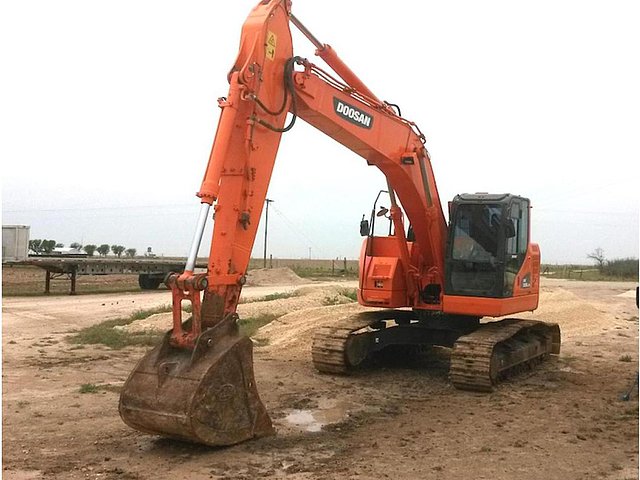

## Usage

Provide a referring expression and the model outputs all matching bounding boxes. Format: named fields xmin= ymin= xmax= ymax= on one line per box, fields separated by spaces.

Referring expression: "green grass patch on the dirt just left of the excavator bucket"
xmin=68 ymin=305 xmax=171 ymax=349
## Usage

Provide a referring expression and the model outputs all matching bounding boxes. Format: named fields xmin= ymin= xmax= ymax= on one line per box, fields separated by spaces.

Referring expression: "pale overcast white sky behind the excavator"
xmin=0 ymin=0 xmax=640 ymax=263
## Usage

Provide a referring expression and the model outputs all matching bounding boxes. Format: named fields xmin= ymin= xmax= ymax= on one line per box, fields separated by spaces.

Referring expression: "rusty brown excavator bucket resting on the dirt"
xmin=119 ymin=315 xmax=274 ymax=446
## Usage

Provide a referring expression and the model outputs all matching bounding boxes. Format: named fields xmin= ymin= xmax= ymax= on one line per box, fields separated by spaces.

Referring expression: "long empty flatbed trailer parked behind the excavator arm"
xmin=3 ymin=256 xmax=207 ymax=295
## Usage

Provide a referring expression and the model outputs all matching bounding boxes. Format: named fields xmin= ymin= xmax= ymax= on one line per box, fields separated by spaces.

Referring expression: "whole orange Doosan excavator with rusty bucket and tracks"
xmin=119 ymin=0 xmax=560 ymax=446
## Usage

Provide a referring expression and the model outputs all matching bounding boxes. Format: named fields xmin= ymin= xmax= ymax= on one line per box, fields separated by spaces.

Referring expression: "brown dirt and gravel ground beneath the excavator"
xmin=2 ymin=280 xmax=638 ymax=480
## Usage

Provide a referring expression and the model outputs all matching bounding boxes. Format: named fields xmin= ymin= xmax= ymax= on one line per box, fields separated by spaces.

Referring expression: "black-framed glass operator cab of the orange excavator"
xmin=445 ymin=194 xmax=531 ymax=298
